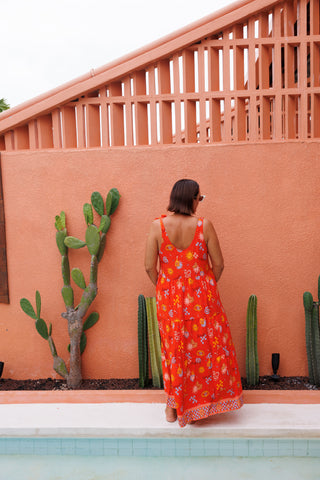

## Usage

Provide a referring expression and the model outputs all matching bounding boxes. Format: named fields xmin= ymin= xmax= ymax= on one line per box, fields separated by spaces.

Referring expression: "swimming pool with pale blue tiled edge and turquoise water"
xmin=0 ymin=438 xmax=320 ymax=480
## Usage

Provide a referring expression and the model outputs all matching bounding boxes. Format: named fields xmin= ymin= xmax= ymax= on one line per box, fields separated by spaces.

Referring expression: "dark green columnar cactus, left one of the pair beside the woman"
xmin=138 ymin=295 xmax=149 ymax=388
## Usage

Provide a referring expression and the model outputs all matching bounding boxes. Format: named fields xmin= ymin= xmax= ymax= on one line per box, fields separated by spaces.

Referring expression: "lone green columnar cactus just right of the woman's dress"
xmin=246 ymin=295 xmax=259 ymax=385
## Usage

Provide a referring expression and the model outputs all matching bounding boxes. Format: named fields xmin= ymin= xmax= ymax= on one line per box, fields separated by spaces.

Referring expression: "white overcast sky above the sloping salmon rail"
xmin=0 ymin=0 xmax=233 ymax=107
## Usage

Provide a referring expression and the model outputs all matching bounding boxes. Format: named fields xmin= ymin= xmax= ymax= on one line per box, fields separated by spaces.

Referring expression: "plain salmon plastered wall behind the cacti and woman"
xmin=0 ymin=142 xmax=320 ymax=379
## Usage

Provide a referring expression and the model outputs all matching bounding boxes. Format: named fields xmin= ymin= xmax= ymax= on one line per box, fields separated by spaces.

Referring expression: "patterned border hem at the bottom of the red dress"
xmin=167 ymin=394 xmax=243 ymax=427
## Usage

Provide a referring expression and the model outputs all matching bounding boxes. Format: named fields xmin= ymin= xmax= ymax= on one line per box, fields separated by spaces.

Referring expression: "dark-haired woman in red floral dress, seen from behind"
xmin=145 ymin=179 xmax=243 ymax=427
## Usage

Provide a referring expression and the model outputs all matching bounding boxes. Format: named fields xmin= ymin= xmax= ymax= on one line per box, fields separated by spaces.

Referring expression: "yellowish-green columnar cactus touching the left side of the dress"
xmin=146 ymin=297 xmax=163 ymax=388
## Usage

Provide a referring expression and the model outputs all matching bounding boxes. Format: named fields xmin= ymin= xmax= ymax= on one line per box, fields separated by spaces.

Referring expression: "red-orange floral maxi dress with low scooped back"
xmin=157 ymin=218 xmax=243 ymax=427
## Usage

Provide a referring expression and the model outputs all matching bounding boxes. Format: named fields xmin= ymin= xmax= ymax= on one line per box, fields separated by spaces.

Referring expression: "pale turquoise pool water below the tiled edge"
xmin=0 ymin=455 xmax=320 ymax=480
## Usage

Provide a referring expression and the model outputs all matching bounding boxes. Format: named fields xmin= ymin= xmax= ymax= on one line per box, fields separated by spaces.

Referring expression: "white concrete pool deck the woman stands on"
xmin=0 ymin=403 xmax=320 ymax=439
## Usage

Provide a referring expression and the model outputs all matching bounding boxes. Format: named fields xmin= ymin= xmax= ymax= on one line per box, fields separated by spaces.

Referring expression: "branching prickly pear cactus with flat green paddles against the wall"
xmin=20 ymin=188 xmax=120 ymax=388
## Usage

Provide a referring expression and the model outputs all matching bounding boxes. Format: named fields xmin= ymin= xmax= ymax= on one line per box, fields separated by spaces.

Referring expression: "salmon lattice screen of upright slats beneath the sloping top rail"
xmin=0 ymin=0 xmax=320 ymax=151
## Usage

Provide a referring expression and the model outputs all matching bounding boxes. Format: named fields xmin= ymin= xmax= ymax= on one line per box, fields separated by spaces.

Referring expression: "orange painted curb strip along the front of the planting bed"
xmin=0 ymin=390 xmax=320 ymax=404
